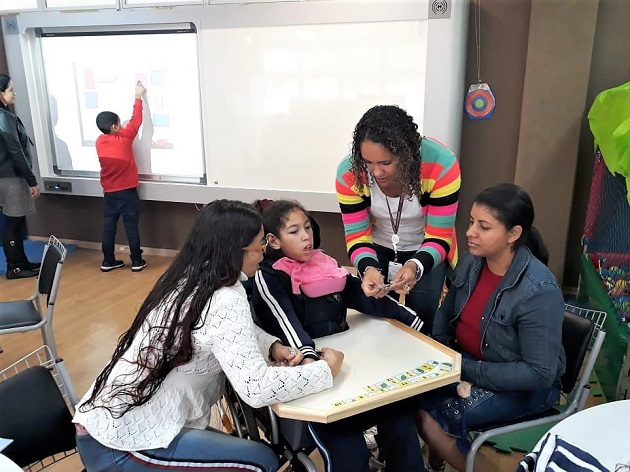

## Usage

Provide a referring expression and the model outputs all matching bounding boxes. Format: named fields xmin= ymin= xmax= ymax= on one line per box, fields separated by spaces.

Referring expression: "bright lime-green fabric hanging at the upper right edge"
xmin=588 ymin=82 xmax=630 ymax=203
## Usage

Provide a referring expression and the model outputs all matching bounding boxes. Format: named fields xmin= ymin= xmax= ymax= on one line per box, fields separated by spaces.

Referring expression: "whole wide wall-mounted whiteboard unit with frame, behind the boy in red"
xmin=3 ymin=0 xmax=468 ymax=212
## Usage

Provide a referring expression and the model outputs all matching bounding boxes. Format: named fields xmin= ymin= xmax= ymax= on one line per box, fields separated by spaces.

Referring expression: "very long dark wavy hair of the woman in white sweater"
xmin=81 ymin=200 xmax=262 ymax=418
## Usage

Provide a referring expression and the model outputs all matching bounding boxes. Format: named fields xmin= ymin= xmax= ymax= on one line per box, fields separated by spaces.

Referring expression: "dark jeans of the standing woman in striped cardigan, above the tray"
xmin=374 ymin=244 xmax=446 ymax=335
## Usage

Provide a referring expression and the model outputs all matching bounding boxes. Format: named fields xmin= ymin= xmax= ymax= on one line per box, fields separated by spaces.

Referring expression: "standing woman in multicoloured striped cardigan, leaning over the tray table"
xmin=336 ymin=105 xmax=461 ymax=334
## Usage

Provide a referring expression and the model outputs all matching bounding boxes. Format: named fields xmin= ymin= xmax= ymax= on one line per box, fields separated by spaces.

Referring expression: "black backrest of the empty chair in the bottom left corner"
xmin=0 ymin=365 xmax=76 ymax=467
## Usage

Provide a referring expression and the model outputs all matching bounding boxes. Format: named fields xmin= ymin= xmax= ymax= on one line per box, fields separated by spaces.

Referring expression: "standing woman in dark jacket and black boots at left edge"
xmin=0 ymin=74 xmax=41 ymax=279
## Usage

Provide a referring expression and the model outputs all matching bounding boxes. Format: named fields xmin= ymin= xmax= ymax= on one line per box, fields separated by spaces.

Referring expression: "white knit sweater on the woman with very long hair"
xmin=73 ymin=282 xmax=332 ymax=451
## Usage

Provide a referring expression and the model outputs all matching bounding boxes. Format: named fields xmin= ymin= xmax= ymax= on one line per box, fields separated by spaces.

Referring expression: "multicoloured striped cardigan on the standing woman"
xmin=336 ymin=137 xmax=461 ymax=273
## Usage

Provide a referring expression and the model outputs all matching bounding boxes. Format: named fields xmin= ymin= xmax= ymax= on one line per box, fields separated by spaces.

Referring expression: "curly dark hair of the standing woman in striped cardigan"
xmin=350 ymin=105 xmax=422 ymax=197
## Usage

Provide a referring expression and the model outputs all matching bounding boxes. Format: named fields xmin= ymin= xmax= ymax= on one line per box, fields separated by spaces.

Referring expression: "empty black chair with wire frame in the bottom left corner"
xmin=0 ymin=346 xmax=82 ymax=472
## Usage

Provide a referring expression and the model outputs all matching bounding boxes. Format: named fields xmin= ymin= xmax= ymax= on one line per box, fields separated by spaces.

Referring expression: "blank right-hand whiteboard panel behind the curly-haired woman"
xmin=202 ymin=21 xmax=427 ymax=196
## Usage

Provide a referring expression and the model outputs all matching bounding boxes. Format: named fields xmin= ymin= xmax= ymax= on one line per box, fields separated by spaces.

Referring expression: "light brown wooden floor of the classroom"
xmin=0 ymin=248 xmax=544 ymax=472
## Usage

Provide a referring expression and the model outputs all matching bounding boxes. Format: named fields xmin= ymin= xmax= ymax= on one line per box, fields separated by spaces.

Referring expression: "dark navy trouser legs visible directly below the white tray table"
xmin=309 ymin=402 xmax=425 ymax=472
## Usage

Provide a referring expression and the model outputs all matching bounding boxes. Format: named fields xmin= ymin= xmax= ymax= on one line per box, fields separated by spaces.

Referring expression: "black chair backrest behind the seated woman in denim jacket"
xmin=561 ymin=311 xmax=595 ymax=394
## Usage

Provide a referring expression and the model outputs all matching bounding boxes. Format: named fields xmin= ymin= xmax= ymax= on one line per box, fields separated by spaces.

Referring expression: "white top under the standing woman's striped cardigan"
xmin=370 ymin=179 xmax=426 ymax=251
